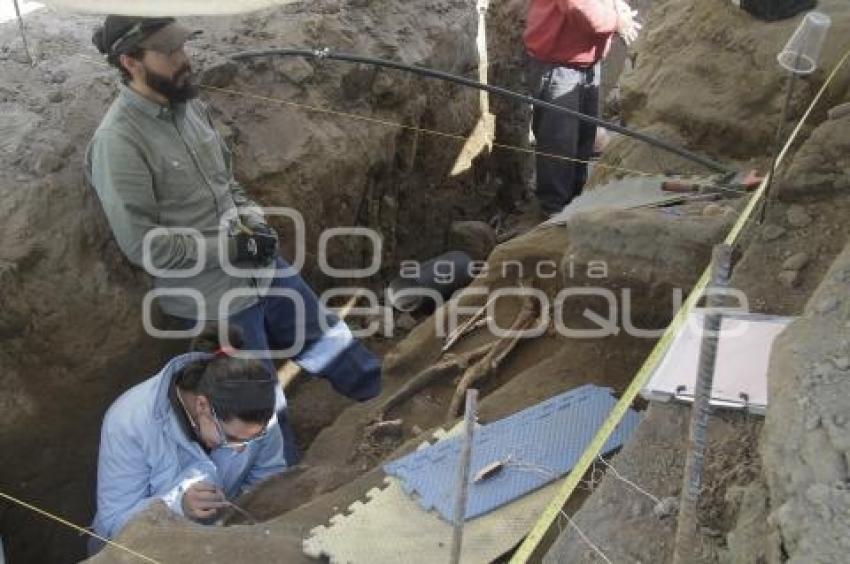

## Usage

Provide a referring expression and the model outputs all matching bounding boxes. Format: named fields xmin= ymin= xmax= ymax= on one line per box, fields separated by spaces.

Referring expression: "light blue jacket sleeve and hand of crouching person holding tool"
xmin=95 ymin=415 xmax=210 ymax=539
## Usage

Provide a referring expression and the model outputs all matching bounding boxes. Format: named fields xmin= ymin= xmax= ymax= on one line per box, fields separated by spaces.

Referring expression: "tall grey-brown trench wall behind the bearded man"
xmin=0 ymin=0 xmax=506 ymax=562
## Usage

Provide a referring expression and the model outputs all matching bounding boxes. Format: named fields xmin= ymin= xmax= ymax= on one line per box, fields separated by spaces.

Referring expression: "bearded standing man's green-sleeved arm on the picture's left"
xmin=90 ymin=129 xmax=219 ymax=276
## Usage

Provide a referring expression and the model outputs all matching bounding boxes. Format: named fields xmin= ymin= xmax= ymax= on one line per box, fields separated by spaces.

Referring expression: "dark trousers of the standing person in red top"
xmin=526 ymin=56 xmax=600 ymax=213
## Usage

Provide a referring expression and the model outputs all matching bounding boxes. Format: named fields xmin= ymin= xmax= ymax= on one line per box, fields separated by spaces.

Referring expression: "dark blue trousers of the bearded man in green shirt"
xmin=176 ymin=258 xmax=381 ymax=465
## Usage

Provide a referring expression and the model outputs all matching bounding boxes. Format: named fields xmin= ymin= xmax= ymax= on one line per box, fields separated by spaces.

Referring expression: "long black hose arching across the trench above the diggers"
xmin=231 ymin=49 xmax=732 ymax=173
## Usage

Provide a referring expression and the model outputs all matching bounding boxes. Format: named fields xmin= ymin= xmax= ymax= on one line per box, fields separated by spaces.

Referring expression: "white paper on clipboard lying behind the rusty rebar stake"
xmin=641 ymin=309 xmax=794 ymax=415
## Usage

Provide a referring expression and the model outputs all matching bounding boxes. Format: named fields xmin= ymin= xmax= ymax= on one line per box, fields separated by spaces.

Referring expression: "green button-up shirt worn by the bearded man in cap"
xmin=86 ymin=85 xmax=270 ymax=319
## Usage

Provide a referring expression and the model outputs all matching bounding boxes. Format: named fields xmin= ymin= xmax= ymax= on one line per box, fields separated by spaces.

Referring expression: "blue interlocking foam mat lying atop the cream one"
xmin=384 ymin=385 xmax=640 ymax=522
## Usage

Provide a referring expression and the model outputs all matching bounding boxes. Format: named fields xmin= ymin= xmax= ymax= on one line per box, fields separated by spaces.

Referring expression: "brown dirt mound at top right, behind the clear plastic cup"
xmin=600 ymin=0 xmax=850 ymax=185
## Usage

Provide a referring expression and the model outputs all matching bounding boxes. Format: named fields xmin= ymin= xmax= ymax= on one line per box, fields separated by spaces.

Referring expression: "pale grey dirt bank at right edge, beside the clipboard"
xmin=761 ymin=245 xmax=850 ymax=563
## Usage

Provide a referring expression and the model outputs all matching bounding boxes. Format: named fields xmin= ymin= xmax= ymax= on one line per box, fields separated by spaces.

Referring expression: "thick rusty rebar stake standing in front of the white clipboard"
xmin=673 ymin=244 xmax=732 ymax=564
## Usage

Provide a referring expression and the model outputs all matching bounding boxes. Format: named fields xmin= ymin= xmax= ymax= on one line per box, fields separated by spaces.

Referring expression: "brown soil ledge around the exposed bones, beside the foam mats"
xmin=84 ymin=191 xmax=728 ymax=562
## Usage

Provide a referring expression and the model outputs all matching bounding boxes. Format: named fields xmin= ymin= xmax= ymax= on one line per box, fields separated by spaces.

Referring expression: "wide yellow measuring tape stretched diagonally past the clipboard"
xmin=510 ymin=45 xmax=850 ymax=564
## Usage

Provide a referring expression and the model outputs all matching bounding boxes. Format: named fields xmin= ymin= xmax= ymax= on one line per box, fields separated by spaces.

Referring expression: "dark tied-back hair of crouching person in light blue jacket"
xmin=176 ymin=324 xmax=277 ymax=423
